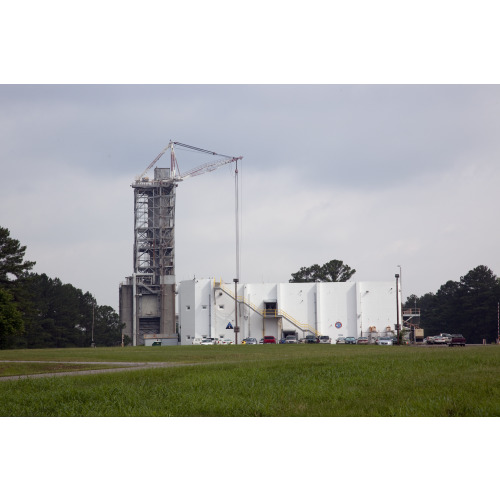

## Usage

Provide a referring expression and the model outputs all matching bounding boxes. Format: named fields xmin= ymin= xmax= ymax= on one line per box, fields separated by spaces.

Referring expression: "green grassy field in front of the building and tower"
xmin=0 ymin=345 xmax=500 ymax=417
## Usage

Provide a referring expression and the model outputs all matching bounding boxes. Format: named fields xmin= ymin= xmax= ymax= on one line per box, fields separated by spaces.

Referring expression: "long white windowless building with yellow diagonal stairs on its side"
xmin=177 ymin=279 xmax=401 ymax=345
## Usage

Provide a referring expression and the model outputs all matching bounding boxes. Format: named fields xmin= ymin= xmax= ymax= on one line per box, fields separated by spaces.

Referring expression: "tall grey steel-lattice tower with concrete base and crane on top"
xmin=120 ymin=141 xmax=242 ymax=345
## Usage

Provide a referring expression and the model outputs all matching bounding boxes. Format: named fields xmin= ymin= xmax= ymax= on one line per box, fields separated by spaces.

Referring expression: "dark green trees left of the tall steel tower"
xmin=0 ymin=227 xmax=130 ymax=349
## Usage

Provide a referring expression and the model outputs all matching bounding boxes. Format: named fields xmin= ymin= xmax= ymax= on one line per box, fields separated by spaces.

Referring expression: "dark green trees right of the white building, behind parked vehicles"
xmin=404 ymin=266 xmax=500 ymax=344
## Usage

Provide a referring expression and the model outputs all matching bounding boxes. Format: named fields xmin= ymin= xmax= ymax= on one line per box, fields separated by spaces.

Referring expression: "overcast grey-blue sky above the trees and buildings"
xmin=0 ymin=85 xmax=500 ymax=308
